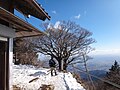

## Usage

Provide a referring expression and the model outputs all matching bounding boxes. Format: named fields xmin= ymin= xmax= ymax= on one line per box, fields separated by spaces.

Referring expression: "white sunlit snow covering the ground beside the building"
xmin=12 ymin=65 xmax=85 ymax=90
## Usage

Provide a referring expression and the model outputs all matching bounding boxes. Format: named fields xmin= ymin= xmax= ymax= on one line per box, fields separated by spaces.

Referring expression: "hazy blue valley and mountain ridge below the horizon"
xmin=69 ymin=54 xmax=120 ymax=80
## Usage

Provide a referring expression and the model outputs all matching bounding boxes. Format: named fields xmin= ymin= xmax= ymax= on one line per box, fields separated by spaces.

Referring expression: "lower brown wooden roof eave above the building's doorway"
xmin=0 ymin=7 xmax=43 ymax=37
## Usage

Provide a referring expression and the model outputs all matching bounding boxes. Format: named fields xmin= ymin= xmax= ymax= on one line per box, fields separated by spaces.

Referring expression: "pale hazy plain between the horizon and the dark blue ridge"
xmin=87 ymin=54 xmax=120 ymax=71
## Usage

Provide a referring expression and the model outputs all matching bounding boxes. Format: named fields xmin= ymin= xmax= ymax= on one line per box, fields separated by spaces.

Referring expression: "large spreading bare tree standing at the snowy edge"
xmin=33 ymin=21 xmax=95 ymax=70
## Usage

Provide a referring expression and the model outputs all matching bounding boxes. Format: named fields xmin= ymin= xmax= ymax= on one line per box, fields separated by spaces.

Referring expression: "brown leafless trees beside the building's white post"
xmin=14 ymin=38 xmax=38 ymax=65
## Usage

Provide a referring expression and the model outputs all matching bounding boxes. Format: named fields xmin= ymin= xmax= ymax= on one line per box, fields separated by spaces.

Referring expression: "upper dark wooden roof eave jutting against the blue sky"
xmin=14 ymin=0 xmax=50 ymax=20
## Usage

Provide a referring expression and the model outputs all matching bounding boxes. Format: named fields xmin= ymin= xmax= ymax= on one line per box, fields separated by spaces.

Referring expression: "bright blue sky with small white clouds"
xmin=15 ymin=0 xmax=120 ymax=54
